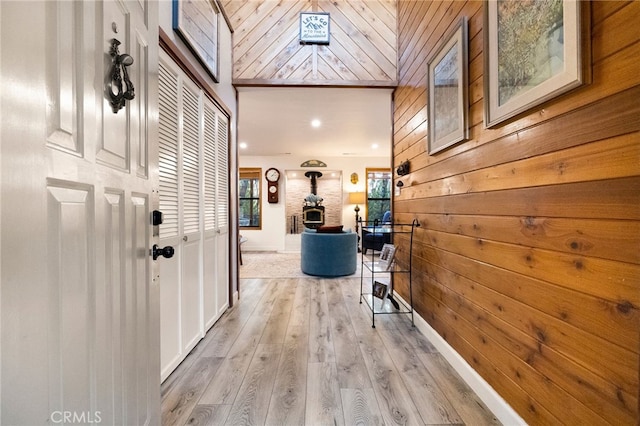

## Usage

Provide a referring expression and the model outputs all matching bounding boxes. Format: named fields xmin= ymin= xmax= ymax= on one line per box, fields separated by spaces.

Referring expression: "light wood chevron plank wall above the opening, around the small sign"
xmin=221 ymin=0 xmax=397 ymax=87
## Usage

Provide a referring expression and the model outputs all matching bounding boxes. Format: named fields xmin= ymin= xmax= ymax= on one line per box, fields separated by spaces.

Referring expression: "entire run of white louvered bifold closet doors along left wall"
xmin=159 ymin=52 xmax=229 ymax=380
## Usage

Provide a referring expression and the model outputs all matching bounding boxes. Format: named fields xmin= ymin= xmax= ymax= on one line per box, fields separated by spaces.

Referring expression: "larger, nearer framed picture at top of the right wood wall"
xmin=484 ymin=0 xmax=587 ymax=127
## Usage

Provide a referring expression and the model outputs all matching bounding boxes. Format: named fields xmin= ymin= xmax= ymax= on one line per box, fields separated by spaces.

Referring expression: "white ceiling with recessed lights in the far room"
xmin=238 ymin=87 xmax=393 ymax=160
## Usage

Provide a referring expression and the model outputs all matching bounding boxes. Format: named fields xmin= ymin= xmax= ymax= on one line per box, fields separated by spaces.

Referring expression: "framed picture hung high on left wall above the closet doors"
xmin=173 ymin=0 xmax=220 ymax=83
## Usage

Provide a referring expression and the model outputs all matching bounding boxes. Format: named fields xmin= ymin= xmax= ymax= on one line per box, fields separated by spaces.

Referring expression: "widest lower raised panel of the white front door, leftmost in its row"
xmin=46 ymin=179 xmax=97 ymax=418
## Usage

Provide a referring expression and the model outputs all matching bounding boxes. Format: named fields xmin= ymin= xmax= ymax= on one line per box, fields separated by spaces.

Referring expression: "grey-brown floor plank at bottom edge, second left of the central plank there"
xmin=227 ymin=344 xmax=282 ymax=425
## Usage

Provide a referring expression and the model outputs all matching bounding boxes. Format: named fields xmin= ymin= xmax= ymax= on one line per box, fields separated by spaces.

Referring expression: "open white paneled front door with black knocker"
xmin=0 ymin=0 xmax=161 ymax=425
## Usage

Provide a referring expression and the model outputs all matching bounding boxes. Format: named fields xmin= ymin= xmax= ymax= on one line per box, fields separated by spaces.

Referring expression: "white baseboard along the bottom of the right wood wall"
xmin=394 ymin=294 xmax=527 ymax=426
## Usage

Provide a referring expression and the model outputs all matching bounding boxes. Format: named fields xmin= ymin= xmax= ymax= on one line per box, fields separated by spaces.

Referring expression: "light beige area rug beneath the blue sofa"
xmin=240 ymin=251 xmax=370 ymax=278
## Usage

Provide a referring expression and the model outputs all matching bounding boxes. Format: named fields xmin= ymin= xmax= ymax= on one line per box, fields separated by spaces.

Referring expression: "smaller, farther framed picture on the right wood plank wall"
xmin=427 ymin=18 xmax=469 ymax=154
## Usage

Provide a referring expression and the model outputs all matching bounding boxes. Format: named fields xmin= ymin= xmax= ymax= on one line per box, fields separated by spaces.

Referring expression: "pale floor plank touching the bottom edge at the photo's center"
xmin=305 ymin=362 xmax=345 ymax=426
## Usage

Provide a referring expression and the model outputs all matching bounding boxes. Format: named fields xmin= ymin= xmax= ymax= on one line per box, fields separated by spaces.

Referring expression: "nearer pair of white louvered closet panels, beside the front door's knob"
xmin=159 ymin=53 xmax=203 ymax=380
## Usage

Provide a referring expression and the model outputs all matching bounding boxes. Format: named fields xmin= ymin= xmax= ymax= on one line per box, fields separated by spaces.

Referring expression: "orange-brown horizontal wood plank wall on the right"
xmin=393 ymin=0 xmax=640 ymax=425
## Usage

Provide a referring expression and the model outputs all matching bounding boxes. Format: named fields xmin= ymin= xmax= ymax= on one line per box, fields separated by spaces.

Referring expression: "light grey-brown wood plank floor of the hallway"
xmin=162 ymin=278 xmax=498 ymax=426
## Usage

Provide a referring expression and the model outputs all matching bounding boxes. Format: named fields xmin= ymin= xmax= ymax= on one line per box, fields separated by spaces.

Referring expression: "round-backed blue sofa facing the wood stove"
xmin=300 ymin=226 xmax=358 ymax=277
